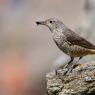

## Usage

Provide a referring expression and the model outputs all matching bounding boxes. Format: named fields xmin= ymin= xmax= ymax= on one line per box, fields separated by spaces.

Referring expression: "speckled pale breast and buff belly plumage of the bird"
xmin=52 ymin=30 xmax=95 ymax=57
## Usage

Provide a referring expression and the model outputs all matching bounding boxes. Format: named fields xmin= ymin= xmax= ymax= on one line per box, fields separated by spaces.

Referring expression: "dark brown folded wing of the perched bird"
xmin=64 ymin=29 xmax=95 ymax=50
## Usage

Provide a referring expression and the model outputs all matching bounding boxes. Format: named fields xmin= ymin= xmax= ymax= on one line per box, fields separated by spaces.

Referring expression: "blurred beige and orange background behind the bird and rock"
xmin=0 ymin=0 xmax=95 ymax=95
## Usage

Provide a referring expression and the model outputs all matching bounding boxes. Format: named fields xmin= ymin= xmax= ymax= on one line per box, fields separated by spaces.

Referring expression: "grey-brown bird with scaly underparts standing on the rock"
xmin=36 ymin=18 xmax=95 ymax=74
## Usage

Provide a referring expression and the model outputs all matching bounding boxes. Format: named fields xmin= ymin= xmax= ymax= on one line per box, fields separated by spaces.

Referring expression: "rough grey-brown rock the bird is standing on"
xmin=46 ymin=62 xmax=95 ymax=95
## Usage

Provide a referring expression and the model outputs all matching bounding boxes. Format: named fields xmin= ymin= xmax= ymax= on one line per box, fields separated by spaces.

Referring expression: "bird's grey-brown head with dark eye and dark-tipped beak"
xmin=36 ymin=18 xmax=65 ymax=32
